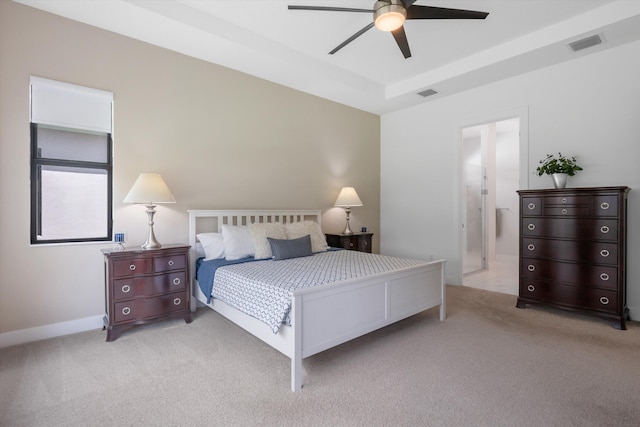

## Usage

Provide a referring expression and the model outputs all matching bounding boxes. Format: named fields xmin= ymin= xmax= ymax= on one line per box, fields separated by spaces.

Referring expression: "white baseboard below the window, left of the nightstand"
xmin=0 ymin=315 xmax=106 ymax=348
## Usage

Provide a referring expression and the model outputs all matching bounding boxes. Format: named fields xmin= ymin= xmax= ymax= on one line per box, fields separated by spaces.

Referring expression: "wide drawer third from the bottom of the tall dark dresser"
xmin=521 ymin=238 xmax=618 ymax=265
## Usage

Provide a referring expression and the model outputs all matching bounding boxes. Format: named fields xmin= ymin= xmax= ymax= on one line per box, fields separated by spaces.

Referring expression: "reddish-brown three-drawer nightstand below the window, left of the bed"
xmin=102 ymin=244 xmax=191 ymax=341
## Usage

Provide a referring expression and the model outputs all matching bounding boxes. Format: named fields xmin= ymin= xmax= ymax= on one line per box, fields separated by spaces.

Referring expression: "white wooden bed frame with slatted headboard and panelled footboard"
xmin=189 ymin=210 xmax=446 ymax=391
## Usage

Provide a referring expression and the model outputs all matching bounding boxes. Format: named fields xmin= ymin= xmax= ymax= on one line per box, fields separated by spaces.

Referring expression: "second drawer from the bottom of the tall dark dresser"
xmin=520 ymin=257 xmax=618 ymax=289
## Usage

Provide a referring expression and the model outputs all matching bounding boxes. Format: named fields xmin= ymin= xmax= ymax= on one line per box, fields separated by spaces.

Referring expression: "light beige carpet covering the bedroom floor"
xmin=0 ymin=286 xmax=640 ymax=426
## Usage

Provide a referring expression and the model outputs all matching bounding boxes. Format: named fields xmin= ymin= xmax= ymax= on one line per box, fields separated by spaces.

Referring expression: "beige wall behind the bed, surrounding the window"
xmin=0 ymin=0 xmax=380 ymax=340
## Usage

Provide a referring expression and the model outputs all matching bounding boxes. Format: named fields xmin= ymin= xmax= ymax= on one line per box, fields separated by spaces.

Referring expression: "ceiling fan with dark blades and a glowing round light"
xmin=289 ymin=0 xmax=489 ymax=59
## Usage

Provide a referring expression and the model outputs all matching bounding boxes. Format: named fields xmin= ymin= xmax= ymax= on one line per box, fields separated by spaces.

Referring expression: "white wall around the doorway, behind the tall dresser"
xmin=380 ymin=42 xmax=640 ymax=319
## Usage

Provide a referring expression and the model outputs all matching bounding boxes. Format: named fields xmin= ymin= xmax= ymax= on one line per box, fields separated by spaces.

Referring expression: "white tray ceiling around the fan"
xmin=14 ymin=0 xmax=640 ymax=114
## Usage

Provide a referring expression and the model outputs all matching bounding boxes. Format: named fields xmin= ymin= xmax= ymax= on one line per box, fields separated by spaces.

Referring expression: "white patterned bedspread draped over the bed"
xmin=212 ymin=250 xmax=426 ymax=333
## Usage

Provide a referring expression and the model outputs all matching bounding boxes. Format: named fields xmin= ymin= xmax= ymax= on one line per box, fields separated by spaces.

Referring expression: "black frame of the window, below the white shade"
xmin=30 ymin=123 xmax=113 ymax=245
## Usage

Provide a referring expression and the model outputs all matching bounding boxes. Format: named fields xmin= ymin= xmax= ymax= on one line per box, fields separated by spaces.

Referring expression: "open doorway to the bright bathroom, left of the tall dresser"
xmin=461 ymin=117 xmax=521 ymax=295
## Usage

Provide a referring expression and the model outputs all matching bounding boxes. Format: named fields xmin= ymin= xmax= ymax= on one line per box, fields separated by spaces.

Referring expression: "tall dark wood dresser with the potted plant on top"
xmin=517 ymin=187 xmax=630 ymax=329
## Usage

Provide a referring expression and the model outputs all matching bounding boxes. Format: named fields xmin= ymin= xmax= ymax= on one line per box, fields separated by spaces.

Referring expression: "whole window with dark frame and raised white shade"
xmin=31 ymin=77 xmax=112 ymax=244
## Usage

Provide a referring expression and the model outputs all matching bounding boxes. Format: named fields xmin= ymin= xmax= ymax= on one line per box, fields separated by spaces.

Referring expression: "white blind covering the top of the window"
xmin=31 ymin=76 xmax=113 ymax=133
